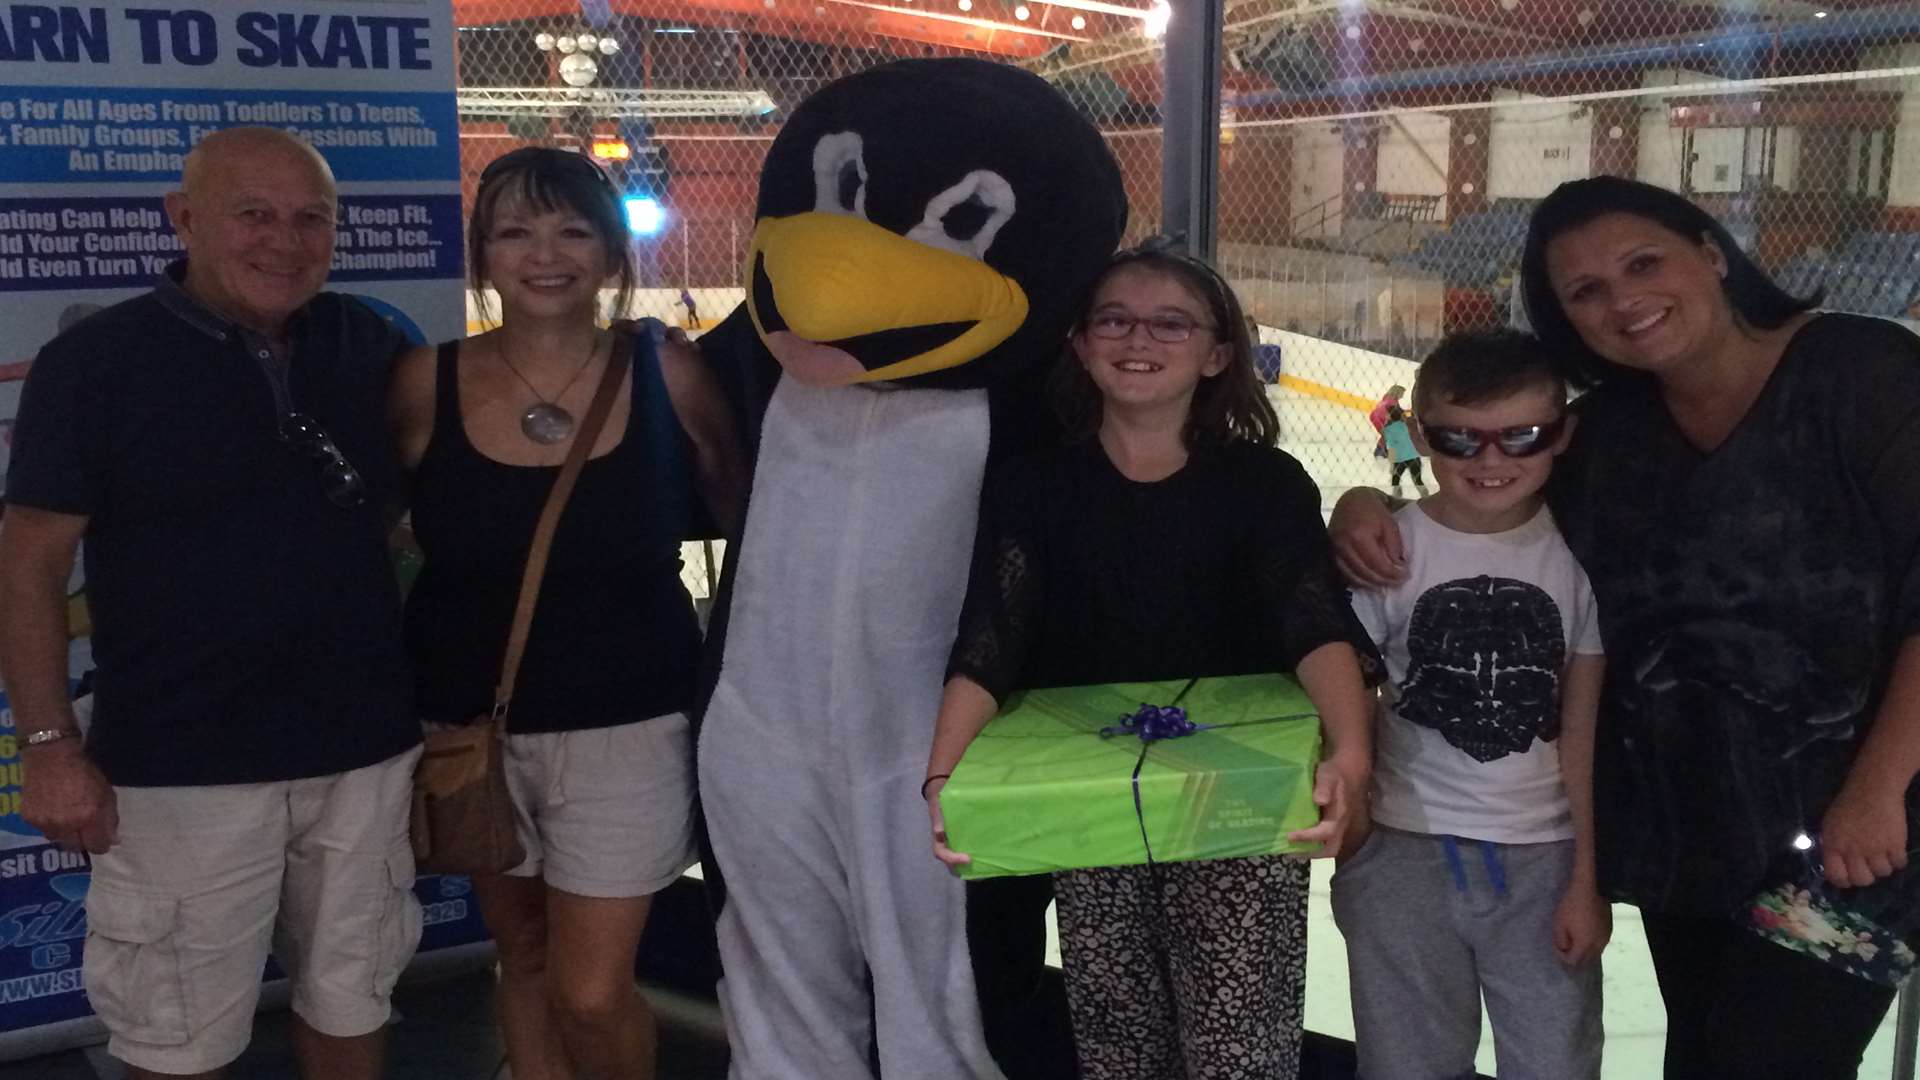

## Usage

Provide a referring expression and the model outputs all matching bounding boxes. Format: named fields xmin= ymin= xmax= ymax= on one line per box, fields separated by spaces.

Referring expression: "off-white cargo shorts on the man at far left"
xmin=83 ymin=748 xmax=420 ymax=1072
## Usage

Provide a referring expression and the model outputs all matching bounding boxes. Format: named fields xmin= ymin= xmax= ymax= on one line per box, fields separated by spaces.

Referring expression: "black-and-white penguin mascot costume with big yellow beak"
xmin=699 ymin=60 xmax=1127 ymax=1080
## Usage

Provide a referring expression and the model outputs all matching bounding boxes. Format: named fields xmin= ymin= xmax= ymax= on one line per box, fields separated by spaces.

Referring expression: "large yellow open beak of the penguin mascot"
xmin=747 ymin=211 xmax=1027 ymax=386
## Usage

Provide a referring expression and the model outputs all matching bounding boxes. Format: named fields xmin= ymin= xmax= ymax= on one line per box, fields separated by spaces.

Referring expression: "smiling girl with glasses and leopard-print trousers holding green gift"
xmin=925 ymin=248 xmax=1371 ymax=1080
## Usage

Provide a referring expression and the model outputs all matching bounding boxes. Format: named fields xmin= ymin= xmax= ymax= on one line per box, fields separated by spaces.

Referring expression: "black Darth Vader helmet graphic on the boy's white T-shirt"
xmin=1400 ymin=577 xmax=1567 ymax=763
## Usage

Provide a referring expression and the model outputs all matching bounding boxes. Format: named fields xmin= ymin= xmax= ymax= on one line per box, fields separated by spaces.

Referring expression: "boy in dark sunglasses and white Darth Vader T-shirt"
xmin=1332 ymin=331 xmax=1611 ymax=1080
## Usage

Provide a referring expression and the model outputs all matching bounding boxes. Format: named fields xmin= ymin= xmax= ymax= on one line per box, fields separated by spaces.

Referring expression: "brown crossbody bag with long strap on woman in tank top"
xmin=407 ymin=334 xmax=632 ymax=874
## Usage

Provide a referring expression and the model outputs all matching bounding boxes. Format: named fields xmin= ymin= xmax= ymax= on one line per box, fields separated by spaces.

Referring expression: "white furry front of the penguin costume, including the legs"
xmin=699 ymin=380 xmax=1002 ymax=1080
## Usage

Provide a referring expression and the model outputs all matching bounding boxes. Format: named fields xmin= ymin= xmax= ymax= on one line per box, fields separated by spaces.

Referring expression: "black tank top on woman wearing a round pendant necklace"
xmin=407 ymin=332 xmax=699 ymax=734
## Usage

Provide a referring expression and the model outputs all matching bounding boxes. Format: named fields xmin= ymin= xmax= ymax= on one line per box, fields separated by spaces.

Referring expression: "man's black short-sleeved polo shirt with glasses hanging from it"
xmin=6 ymin=263 xmax=420 ymax=786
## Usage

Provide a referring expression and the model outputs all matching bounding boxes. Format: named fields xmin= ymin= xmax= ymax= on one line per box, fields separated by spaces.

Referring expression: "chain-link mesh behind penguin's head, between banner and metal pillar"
xmin=455 ymin=0 xmax=1162 ymax=600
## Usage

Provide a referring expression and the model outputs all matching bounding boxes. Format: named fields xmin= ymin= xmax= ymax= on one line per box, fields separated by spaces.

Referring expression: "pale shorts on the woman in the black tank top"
xmin=507 ymin=713 xmax=695 ymax=897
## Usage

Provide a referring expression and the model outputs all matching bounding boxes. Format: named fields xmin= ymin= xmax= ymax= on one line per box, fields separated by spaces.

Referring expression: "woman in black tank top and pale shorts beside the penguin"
xmin=392 ymin=146 xmax=743 ymax=1080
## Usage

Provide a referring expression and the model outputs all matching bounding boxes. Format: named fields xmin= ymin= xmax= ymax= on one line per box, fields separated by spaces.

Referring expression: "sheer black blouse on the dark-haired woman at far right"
xmin=1549 ymin=315 xmax=1920 ymax=940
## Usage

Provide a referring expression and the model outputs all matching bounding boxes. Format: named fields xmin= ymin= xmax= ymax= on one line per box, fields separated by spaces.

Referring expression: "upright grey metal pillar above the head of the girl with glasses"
xmin=1160 ymin=0 xmax=1227 ymax=259
